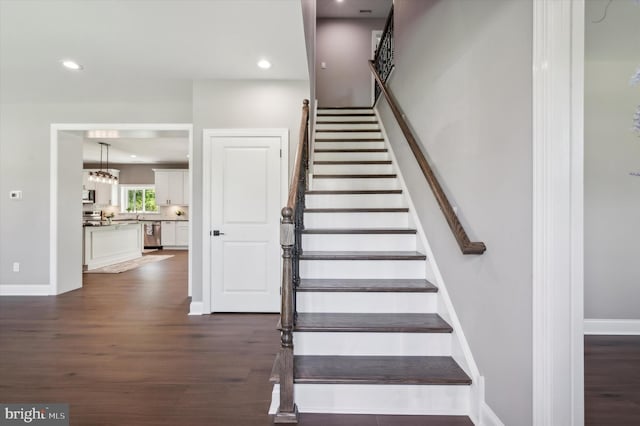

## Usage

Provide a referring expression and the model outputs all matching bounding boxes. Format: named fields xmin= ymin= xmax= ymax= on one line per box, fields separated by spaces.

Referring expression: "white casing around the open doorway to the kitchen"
xmin=49 ymin=123 xmax=193 ymax=296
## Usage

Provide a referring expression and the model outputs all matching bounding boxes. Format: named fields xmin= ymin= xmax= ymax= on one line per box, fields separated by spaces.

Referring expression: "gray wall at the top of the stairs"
xmin=316 ymin=18 xmax=385 ymax=107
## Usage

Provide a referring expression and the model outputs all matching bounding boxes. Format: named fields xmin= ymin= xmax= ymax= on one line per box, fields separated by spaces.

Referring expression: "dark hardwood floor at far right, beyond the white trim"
xmin=584 ymin=336 xmax=640 ymax=426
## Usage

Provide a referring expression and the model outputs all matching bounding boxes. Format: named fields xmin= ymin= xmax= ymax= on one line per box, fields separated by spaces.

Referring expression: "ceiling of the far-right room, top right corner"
xmin=585 ymin=0 xmax=640 ymax=60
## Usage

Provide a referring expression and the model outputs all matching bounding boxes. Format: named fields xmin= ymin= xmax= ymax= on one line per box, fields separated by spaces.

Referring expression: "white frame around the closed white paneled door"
xmin=202 ymin=128 xmax=289 ymax=314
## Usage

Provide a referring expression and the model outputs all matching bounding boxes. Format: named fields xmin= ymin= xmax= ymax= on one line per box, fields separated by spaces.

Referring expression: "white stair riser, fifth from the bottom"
xmin=302 ymin=234 xmax=416 ymax=251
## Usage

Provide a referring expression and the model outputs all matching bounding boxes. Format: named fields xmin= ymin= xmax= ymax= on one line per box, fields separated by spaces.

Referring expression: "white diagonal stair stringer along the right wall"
xmin=373 ymin=106 xmax=485 ymax=424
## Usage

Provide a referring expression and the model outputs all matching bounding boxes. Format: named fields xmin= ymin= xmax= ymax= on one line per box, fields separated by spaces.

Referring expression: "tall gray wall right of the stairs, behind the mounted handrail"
xmin=379 ymin=0 xmax=533 ymax=426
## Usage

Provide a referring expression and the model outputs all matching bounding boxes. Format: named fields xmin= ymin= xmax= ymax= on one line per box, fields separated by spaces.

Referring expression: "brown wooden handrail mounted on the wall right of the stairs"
xmin=369 ymin=61 xmax=487 ymax=254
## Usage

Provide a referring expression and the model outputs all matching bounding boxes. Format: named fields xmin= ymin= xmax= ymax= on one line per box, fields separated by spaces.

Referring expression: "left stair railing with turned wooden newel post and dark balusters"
xmin=274 ymin=99 xmax=309 ymax=423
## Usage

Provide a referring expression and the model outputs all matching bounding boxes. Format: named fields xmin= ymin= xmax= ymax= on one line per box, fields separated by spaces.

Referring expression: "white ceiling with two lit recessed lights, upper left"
xmin=0 ymin=0 xmax=309 ymax=102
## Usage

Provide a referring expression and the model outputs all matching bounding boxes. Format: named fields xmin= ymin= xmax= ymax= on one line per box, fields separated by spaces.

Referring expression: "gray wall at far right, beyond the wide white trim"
xmin=584 ymin=59 xmax=640 ymax=319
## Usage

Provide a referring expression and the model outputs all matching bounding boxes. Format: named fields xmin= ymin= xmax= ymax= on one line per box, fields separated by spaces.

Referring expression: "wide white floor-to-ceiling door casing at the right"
xmin=532 ymin=0 xmax=585 ymax=426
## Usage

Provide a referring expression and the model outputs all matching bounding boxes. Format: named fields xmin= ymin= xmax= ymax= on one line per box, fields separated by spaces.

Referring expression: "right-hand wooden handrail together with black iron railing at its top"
xmin=369 ymin=7 xmax=487 ymax=254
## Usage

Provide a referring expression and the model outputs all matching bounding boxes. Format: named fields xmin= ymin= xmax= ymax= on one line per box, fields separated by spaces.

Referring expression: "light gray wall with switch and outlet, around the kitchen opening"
xmin=0 ymin=99 xmax=191 ymax=285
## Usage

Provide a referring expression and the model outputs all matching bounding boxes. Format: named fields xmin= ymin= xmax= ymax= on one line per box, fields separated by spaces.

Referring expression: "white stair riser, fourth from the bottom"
xmin=300 ymin=260 xmax=426 ymax=279
